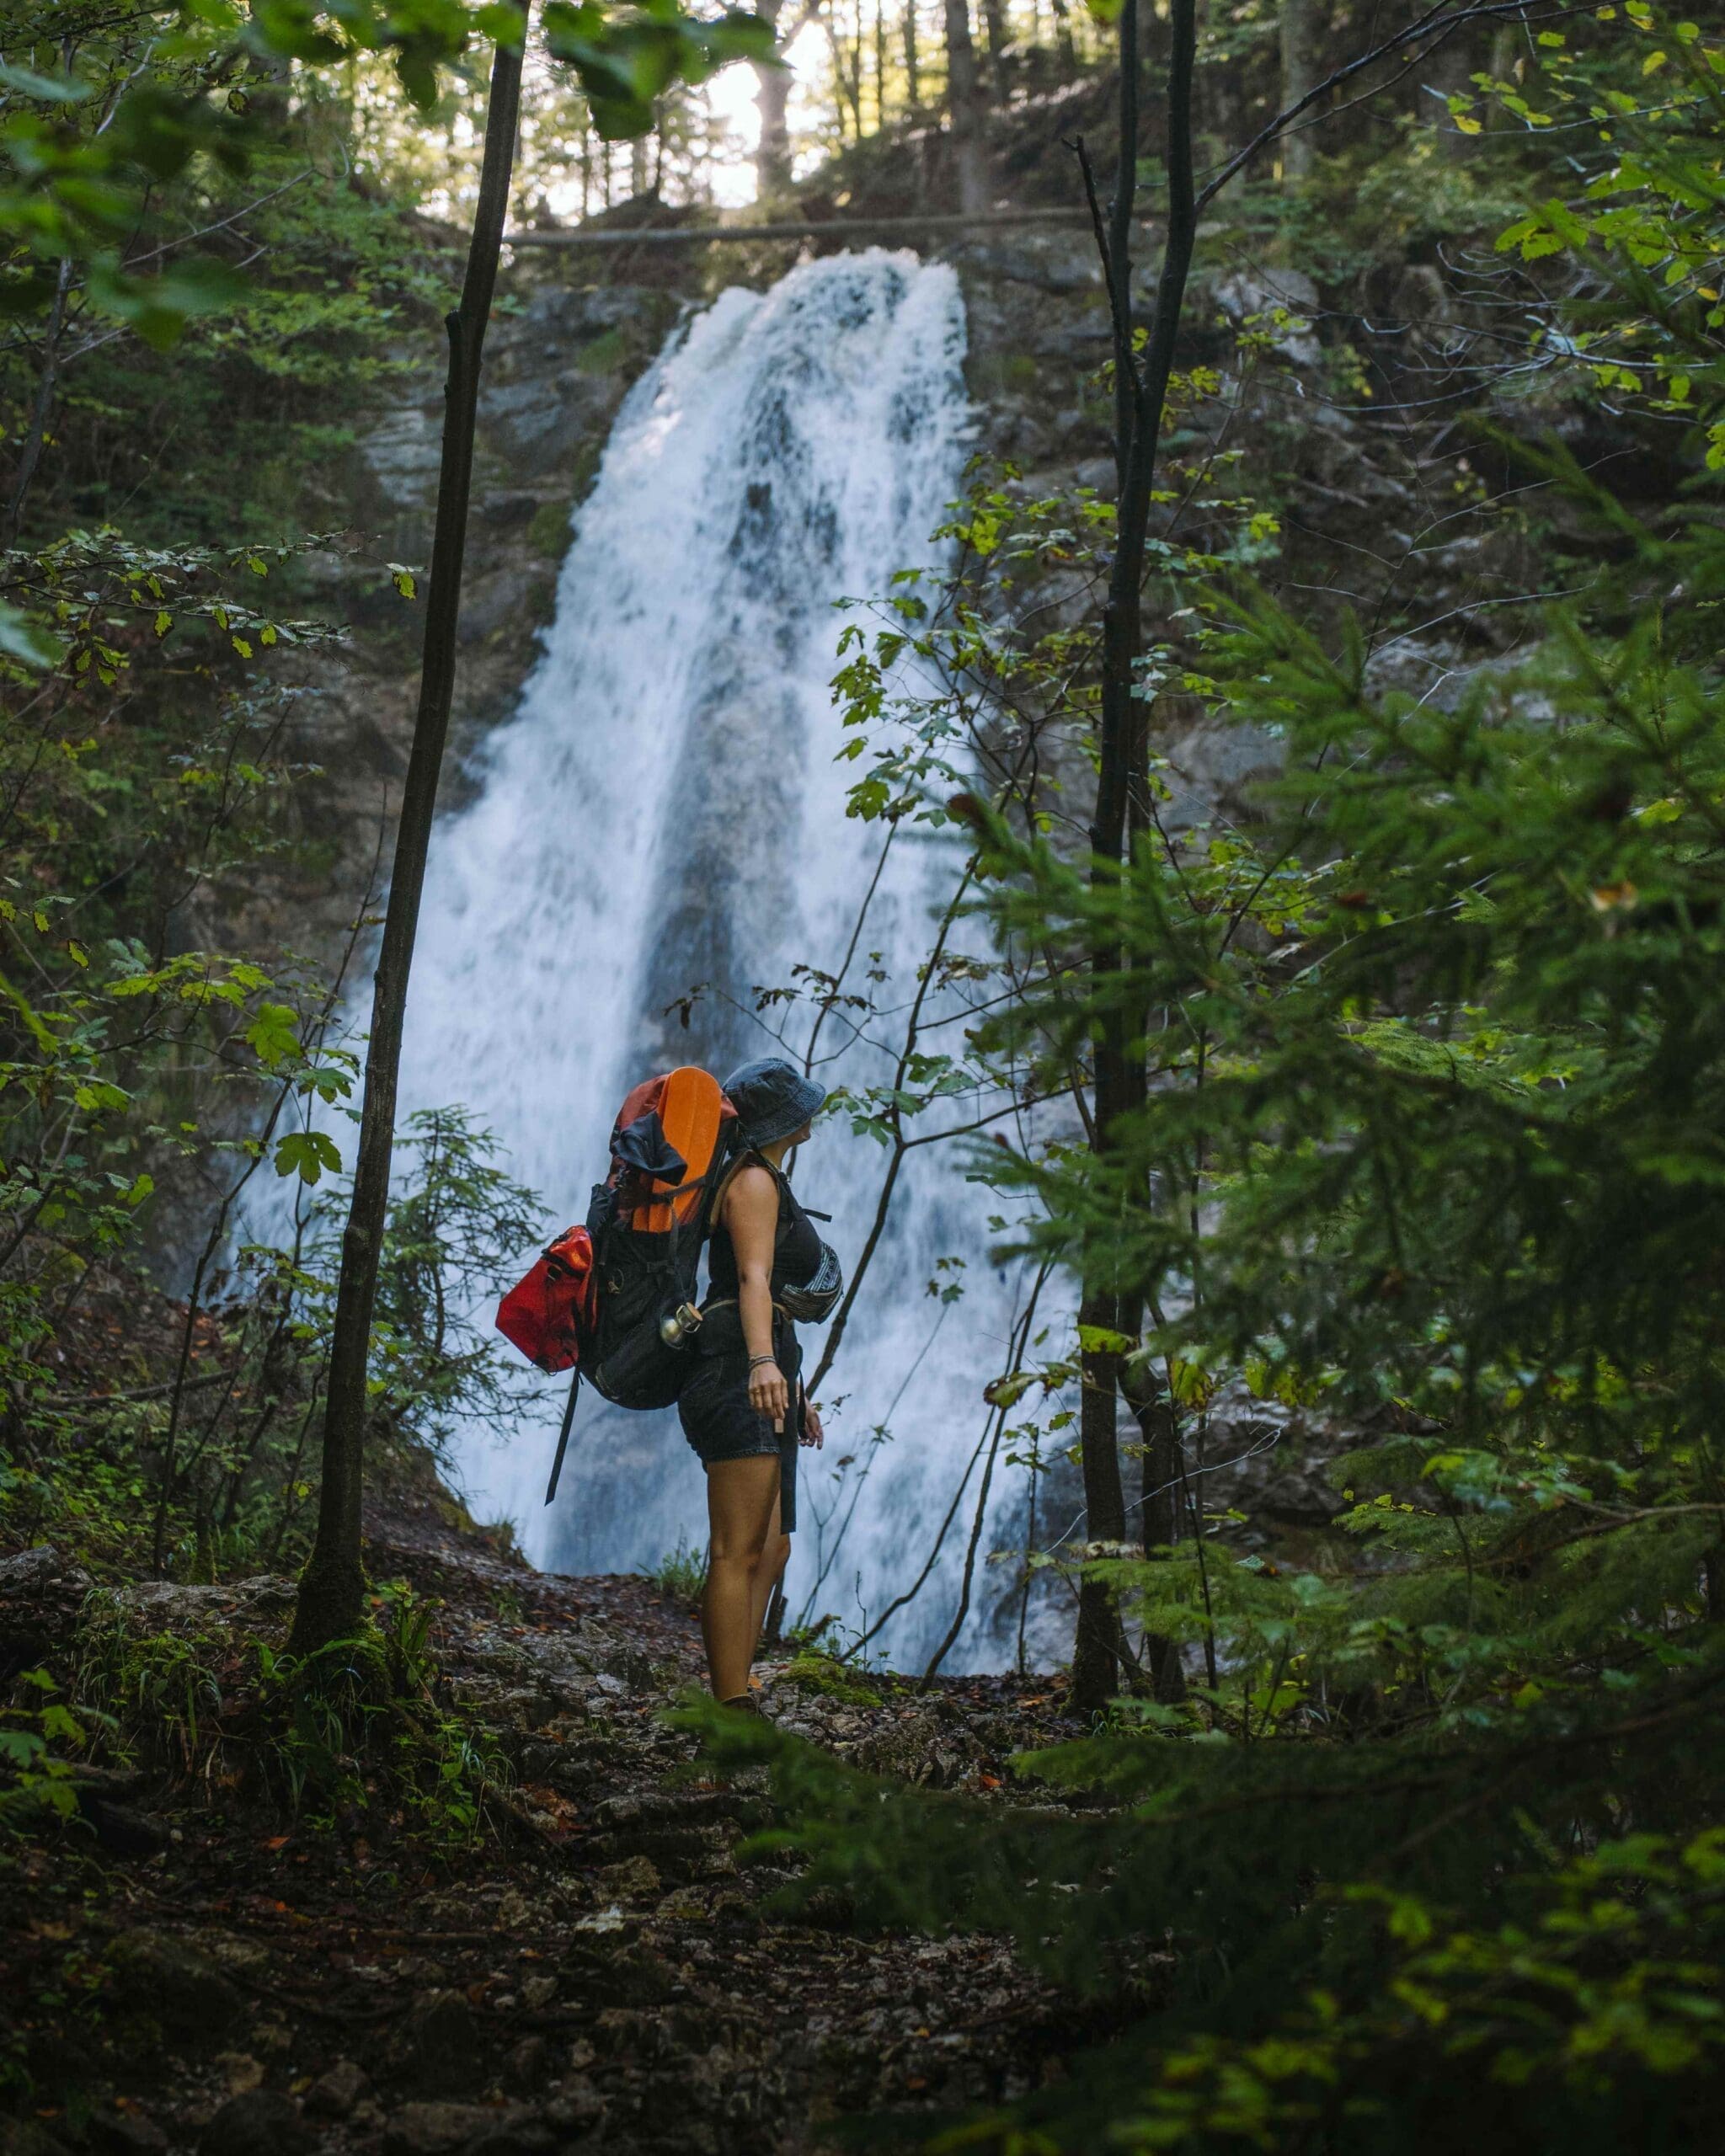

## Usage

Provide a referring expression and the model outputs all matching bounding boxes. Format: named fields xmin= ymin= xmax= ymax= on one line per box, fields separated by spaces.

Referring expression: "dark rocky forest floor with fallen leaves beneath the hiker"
xmin=0 ymin=1497 xmax=1119 ymax=2156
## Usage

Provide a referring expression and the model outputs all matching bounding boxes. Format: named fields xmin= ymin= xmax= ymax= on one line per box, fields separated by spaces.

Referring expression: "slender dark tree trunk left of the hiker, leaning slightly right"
xmin=291 ymin=22 xmax=526 ymax=1654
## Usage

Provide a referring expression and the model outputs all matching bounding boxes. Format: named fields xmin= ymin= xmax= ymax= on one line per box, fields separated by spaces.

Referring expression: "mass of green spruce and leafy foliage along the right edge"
xmin=694 ymin=8 xmax=1725 ymax=2152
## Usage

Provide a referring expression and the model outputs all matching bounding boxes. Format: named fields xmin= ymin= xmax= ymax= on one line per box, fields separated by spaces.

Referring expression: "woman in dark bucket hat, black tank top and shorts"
xmin=677 ymin=1059 xmax=843 ymax=1712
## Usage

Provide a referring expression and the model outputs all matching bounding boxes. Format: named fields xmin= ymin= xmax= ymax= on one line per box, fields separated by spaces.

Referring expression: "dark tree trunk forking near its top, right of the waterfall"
xmin=1071 ymin=0 xmax=1197 ymax=1712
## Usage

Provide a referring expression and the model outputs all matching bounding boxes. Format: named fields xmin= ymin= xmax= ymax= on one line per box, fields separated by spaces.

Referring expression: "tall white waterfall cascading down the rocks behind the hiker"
xmin=387 ymin=250 xmax=1056 ymax=1668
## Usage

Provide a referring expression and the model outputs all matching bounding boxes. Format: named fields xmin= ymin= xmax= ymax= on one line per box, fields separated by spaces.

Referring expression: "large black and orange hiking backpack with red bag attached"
xmin=496 ymin=1065 xmax=733 ymax=1505
